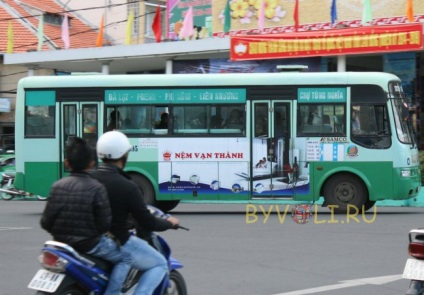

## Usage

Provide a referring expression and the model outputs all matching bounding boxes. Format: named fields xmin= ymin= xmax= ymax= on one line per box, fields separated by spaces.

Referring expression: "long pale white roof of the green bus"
xmin=18 ymin=72 xmax=400 ymax=89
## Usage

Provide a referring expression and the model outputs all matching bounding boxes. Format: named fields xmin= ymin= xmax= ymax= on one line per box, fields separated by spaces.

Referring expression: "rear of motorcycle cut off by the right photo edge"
xmin=402 ymin=229 xmax=424 ymax=295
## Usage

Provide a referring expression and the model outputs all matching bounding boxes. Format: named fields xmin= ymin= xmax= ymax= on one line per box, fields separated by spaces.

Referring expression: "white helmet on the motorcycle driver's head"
xmin=97 ymin=131 xmax=132 ymax=160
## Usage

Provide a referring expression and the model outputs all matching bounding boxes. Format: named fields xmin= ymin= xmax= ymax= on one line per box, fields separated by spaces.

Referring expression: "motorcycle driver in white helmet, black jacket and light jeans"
xmin=92 ymin=131 xmax=179 ymax=295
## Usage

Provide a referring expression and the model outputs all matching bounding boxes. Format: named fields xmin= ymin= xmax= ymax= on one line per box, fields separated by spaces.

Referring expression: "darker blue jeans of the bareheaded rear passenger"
xmin=87 ymin=236 xmax=132 ymax=295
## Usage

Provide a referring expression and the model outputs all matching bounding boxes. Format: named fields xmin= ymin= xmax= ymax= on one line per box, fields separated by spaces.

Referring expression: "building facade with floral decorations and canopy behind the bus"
xmin=0 ymin=0 xmax=424 ymax=148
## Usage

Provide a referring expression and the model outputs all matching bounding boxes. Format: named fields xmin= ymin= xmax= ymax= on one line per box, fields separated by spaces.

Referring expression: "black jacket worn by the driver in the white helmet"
xmin=91 ymin=163 xmax=172 ymax=245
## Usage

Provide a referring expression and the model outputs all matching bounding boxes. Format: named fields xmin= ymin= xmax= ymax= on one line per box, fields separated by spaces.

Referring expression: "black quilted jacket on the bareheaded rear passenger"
xmin=40 ymin=173 xmax=112 ymax=252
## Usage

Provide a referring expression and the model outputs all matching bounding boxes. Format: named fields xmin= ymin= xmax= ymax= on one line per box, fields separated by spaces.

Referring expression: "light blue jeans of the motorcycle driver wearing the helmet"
xmin=121 ymin=236 xmax=168 ymax=295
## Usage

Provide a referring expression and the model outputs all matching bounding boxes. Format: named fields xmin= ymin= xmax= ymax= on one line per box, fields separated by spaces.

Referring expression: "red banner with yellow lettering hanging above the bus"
xmin=230 ymin=23 xmax=423 ymax=60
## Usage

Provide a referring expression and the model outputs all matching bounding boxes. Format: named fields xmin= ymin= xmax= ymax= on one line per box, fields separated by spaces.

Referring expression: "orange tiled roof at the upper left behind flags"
xmin=0 ymin=0 xmax=110 ymax=53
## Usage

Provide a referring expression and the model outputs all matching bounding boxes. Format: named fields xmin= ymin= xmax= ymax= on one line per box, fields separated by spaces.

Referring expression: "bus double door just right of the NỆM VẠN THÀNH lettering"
xmin=250 ymin=101 xmax=297 ymax=199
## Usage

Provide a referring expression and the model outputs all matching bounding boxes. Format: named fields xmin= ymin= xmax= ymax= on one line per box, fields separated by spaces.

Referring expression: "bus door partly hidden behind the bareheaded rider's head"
xmin=60 ymin=102 xmax=102 ymax=177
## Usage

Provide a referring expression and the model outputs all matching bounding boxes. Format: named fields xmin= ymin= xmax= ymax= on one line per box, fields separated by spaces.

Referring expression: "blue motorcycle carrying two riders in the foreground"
xmin=28 ymin=206 xmax=188 ymax=295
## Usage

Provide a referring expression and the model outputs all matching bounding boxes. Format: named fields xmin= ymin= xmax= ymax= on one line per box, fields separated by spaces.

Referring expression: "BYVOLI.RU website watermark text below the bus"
xmin=246 ymin=204 xmax=377 ymax=224
